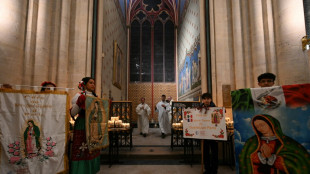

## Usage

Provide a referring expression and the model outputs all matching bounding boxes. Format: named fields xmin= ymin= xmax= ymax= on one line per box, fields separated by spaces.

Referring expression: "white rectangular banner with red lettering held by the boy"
xmin=183 ymin=107 xmax=227 ymax=140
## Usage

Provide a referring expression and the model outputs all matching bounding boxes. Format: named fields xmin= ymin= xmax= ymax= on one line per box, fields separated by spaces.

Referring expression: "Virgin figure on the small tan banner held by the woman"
xmin=89 ymin=101 xmax=104 ymax=145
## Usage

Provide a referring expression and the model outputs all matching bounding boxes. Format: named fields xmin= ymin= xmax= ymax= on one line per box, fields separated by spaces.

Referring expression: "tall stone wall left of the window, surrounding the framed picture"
xmin=97 ymin=0 xmax=127 ymax=101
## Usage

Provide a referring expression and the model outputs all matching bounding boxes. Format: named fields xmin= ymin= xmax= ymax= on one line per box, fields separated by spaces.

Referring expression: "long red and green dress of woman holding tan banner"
xmin=70 ymin=91 xmax=100 ymax=174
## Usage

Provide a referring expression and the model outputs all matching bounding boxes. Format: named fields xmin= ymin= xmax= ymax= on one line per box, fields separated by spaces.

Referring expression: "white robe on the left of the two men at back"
xmin=136 ymin=103 xmax=151 ymax=134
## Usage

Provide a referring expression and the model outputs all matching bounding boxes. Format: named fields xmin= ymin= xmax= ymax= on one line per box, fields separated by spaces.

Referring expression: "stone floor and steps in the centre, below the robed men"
xmin=99 ymin=128 xmax=236 ymax=174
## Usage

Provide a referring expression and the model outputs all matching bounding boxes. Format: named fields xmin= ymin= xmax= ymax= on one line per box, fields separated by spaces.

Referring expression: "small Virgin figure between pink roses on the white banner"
xmin=24 ymin=120 xmax=41 ymax=158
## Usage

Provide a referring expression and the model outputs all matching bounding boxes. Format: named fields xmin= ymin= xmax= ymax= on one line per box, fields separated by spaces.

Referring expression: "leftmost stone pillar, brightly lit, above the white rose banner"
xmin=0 ymin=0 xmax=27 ymax=85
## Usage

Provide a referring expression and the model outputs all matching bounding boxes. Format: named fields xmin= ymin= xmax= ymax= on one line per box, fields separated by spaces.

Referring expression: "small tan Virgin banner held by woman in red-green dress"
xmin=85 ymin=96 xmax=109 ymax=151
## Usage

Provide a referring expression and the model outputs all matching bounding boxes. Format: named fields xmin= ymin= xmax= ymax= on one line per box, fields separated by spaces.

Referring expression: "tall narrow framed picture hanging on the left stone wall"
xmin=113 ymin=41 xmax=123 ymax=89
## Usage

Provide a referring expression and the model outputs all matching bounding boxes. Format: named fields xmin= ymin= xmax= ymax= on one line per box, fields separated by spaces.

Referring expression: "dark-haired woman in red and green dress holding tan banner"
xmin=70 ymin=77 xmax=100 ymax=174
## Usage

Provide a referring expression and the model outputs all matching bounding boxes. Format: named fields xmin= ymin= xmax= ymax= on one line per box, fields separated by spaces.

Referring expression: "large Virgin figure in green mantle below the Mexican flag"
xmin=239 ymin=114 xmax=310 ymax=174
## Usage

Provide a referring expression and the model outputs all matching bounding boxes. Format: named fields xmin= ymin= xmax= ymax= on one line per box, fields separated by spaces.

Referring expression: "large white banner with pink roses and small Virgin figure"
xmin=0 ymin=89 xmax=69 ymax=174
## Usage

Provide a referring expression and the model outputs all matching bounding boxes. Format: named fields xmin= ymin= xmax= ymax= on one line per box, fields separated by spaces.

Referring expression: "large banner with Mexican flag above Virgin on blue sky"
xmin=231 ymin=84 xmax=310 ymax=174
